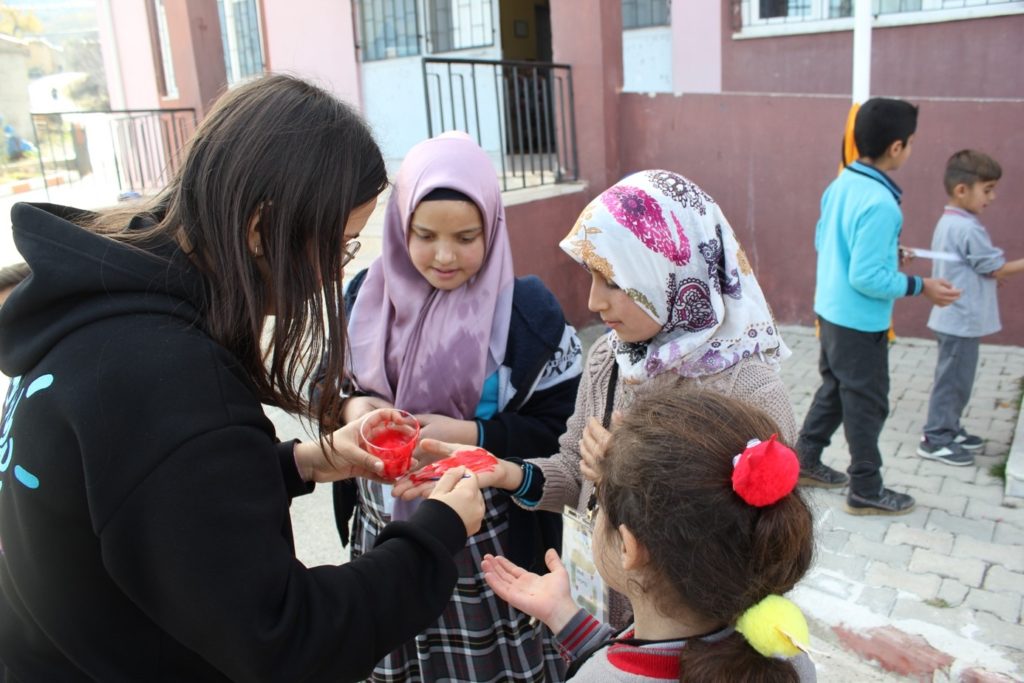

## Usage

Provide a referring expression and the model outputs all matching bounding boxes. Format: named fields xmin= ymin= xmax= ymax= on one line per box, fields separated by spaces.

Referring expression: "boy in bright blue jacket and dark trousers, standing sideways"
xmin=797 ymin=97 xmax=959 ymax=515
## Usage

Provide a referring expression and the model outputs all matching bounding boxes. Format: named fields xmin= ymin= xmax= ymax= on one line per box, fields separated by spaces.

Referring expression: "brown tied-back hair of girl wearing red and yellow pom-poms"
xmin=598 ymin=382 xmax=813 ymax=683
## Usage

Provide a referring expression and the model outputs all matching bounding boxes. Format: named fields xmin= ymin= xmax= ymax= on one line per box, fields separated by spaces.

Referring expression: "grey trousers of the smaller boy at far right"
xmin=925 ymin=332 xmax=981 ymax=445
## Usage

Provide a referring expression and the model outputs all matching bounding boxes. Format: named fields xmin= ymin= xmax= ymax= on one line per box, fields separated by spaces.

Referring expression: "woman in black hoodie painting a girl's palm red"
xmin=0 ymin=76 xmax=483 ymax=681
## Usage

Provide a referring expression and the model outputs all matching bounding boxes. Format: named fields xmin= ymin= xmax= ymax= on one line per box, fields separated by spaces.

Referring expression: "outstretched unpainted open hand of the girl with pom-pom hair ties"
xmin=481 ymin=549 xmax=579 ymax=633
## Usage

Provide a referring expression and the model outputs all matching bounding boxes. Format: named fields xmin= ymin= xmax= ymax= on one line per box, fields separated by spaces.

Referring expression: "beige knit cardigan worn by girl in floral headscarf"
xmin=513 ymin=333 xmax=797 ymax=628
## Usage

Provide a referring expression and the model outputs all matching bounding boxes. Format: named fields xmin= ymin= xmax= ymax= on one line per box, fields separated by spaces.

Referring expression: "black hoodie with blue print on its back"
xmin=0 ymin=204 xmax=466 ymax=681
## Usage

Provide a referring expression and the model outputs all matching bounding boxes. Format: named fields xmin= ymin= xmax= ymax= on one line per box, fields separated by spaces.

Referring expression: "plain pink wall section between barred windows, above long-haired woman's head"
xmin=262 ymin=0 xmax=362 ymax=110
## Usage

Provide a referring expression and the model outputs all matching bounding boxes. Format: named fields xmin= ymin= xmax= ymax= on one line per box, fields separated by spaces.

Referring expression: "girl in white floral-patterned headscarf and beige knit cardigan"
xmin=399 ymin=170 xmax=797 ymax=627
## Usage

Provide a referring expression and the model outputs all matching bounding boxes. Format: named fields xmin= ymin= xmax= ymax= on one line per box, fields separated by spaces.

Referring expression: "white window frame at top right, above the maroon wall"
xmin=732 ymin=0 xmax=1024 ymax=40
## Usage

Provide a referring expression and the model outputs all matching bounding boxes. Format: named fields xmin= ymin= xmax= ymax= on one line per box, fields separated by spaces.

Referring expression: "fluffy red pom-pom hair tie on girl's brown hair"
xmin=732 ymin=434 xmax=800 ymax=508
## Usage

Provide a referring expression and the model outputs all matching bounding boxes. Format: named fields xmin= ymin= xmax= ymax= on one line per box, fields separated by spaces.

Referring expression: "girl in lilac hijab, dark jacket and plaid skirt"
xmin=335 ymin=133 xmax=582 ymax=681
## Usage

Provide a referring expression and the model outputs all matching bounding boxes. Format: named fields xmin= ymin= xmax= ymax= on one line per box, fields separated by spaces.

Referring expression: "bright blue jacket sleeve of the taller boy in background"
xmin=849 ymin=203 xmax=923 ymax=300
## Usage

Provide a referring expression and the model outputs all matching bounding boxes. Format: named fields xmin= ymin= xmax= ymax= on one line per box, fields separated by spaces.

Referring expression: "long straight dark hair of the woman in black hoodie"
xmin=86 ymin=75 xmax=387 ymax=436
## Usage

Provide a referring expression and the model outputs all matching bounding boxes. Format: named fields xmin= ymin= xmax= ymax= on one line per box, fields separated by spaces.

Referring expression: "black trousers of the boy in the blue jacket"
xmin=797 ymin=316 xmax=889 ymax=497
